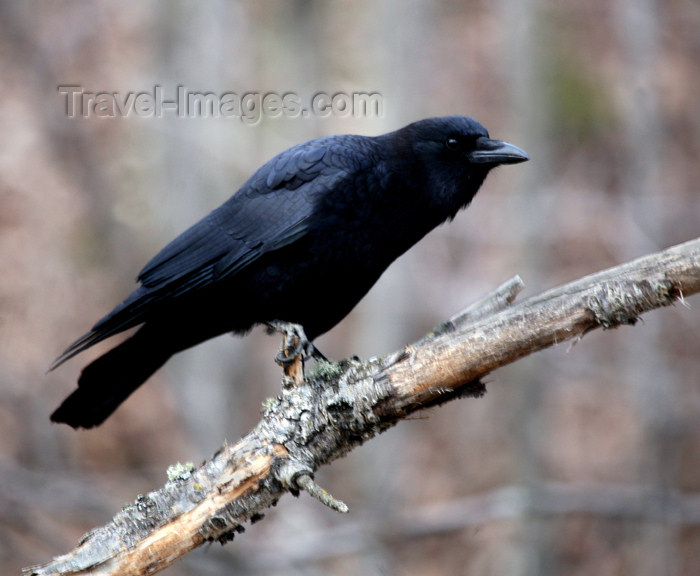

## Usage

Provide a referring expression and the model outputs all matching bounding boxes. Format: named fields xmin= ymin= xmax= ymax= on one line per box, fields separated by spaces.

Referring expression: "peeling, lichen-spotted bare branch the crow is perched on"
xmin=23 ymin=239 xmax=700 ymax=576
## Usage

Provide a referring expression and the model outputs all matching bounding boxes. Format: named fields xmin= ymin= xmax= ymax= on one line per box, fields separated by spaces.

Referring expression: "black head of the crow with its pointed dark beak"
xmin=393 ymin=116 xmax=530 ymax=218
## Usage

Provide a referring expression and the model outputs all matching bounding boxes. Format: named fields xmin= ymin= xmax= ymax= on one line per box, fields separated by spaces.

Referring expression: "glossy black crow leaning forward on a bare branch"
xmin=51 ymin=116 xmax=528 ymax=428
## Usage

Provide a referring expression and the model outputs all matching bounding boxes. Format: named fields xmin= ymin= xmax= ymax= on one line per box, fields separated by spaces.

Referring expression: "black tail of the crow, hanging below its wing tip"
xmin=51 ymin=324 xmax=173 ymax=428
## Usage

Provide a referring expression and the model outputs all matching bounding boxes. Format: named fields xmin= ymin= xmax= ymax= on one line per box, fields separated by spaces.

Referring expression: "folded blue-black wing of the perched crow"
xmin=51 ymin=136 xmax=371 ymax=369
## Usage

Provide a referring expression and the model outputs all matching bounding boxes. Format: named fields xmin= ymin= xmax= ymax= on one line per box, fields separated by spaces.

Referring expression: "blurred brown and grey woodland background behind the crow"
xmin=0 ymin=0 xmax=700 ymax=576
